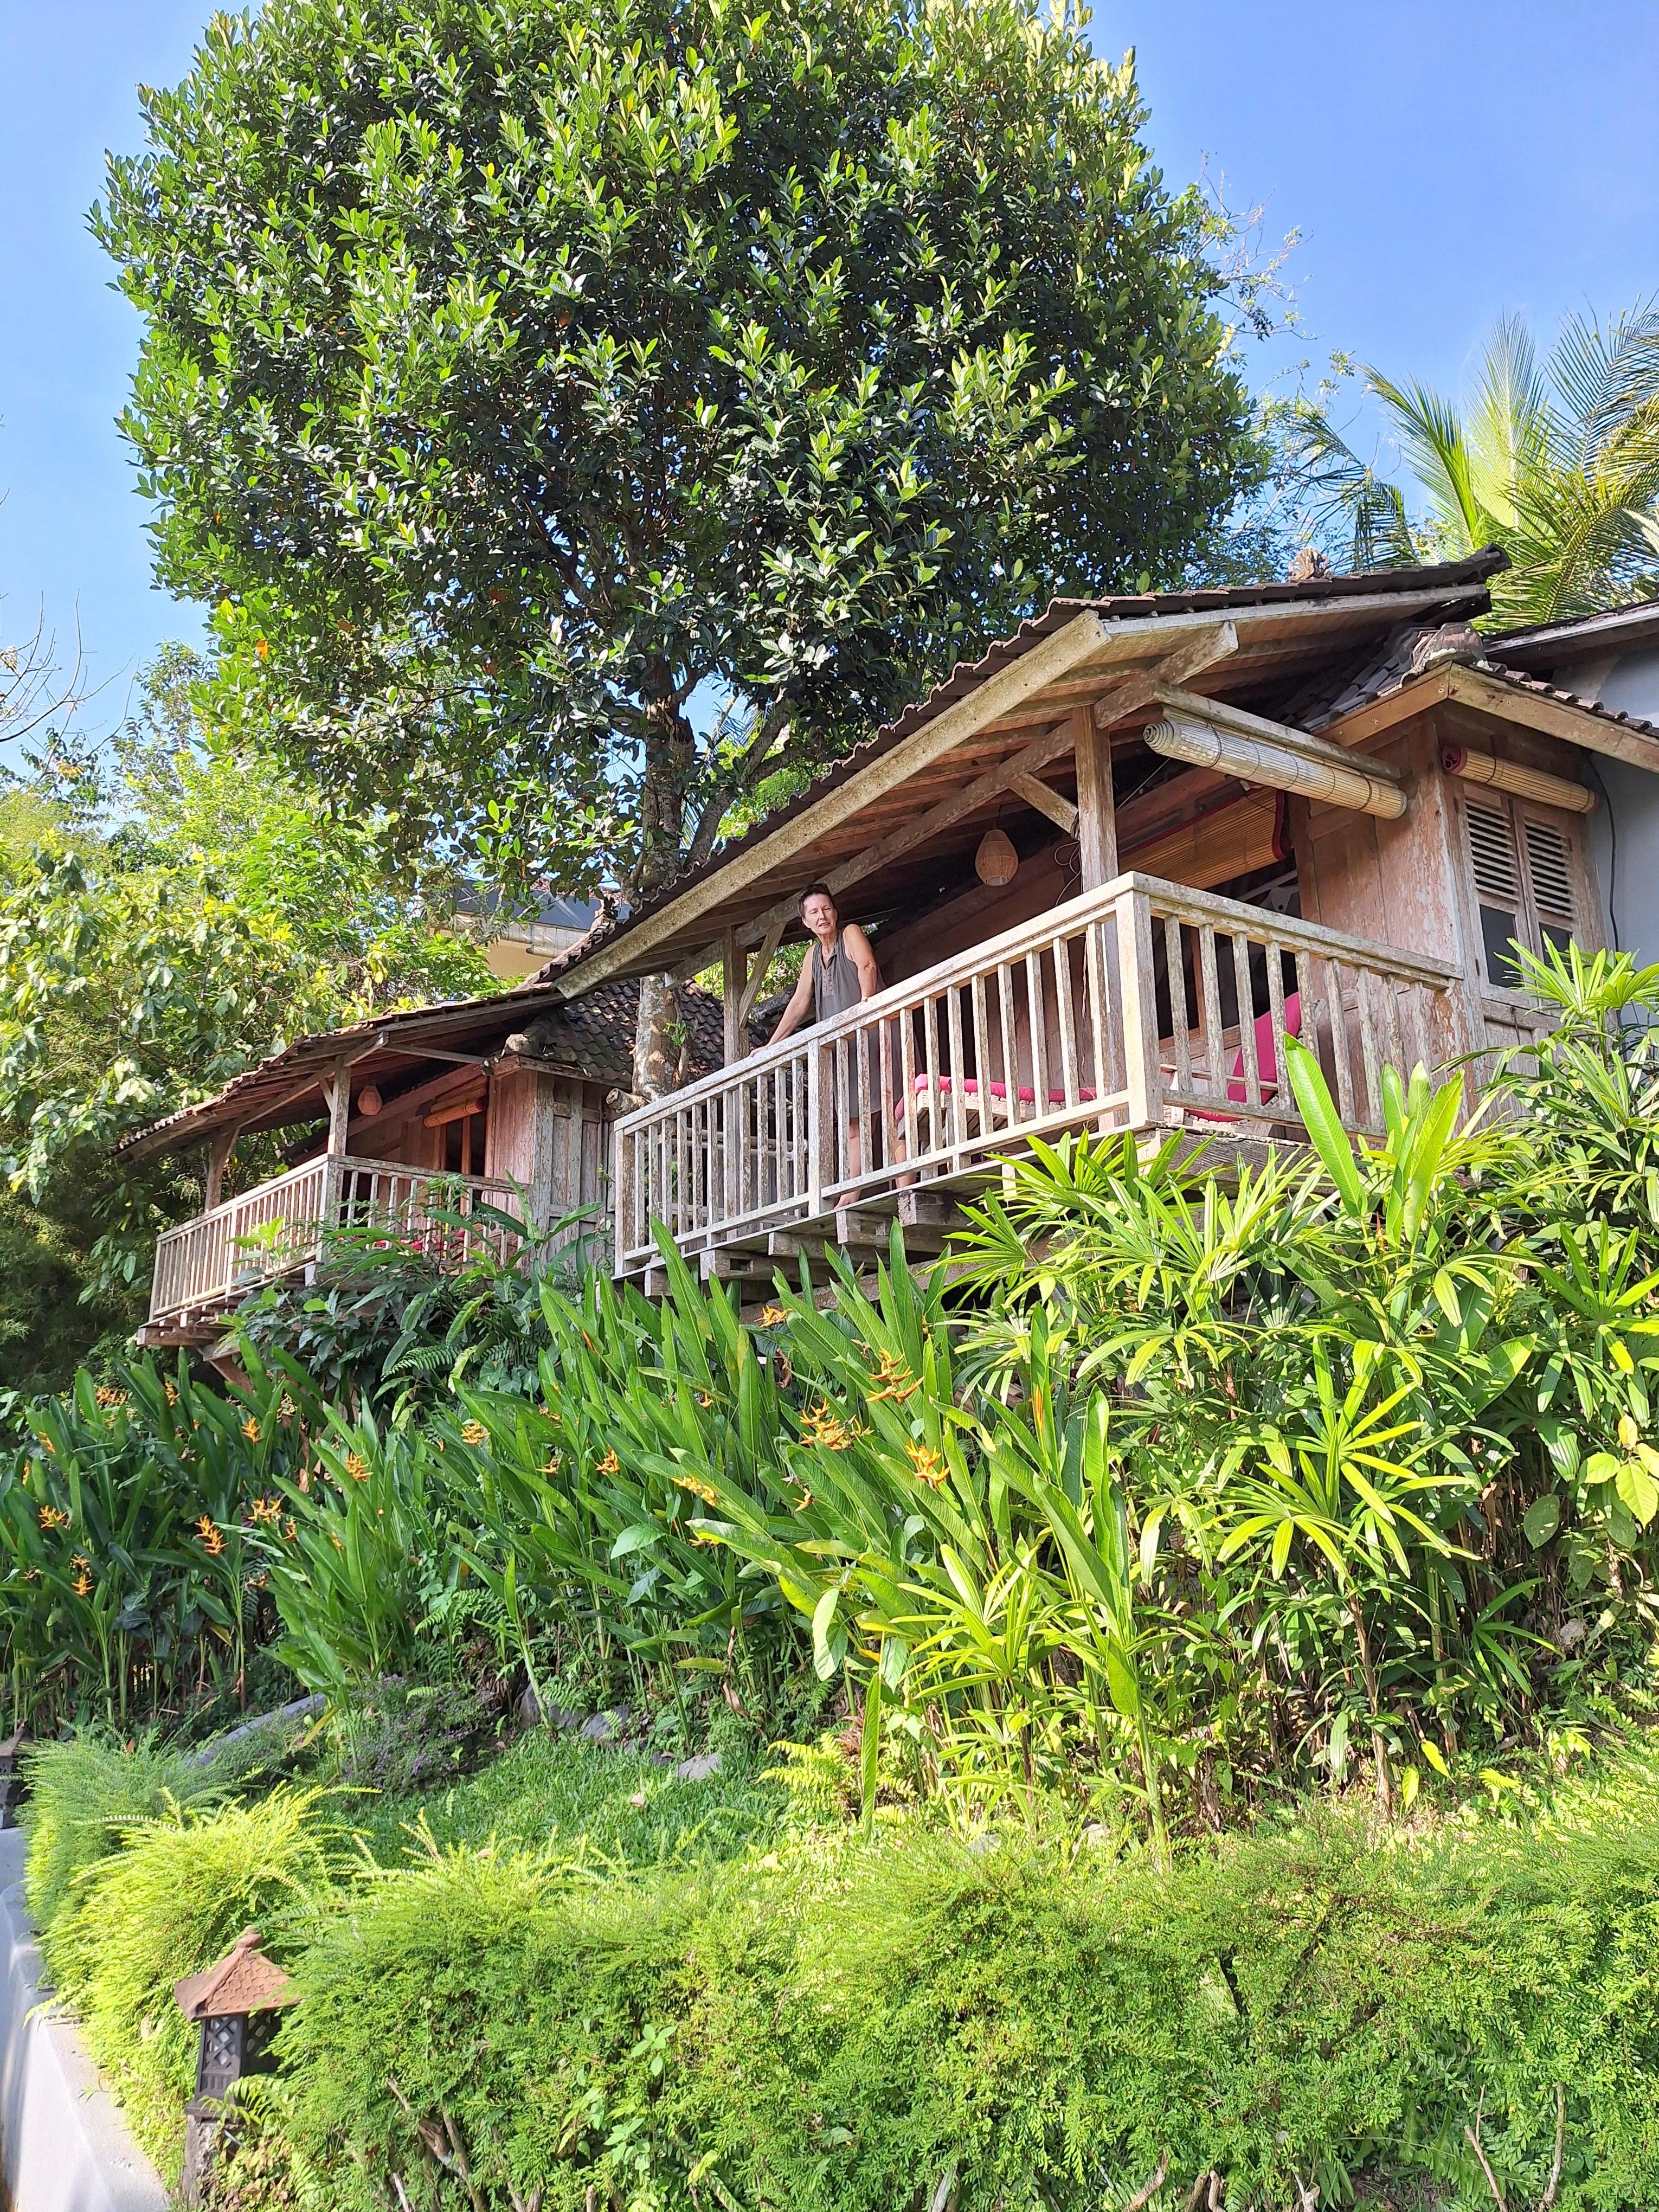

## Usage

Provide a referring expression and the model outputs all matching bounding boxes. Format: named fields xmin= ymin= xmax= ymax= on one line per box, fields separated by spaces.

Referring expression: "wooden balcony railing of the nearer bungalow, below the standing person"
xmin=615 ymin=876 xmax=1462 ymax=1274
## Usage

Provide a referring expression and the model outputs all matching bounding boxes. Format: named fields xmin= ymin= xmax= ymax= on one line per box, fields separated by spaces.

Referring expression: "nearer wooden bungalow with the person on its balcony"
xmin=533 ymin=551 xmax=1659 ymax=1288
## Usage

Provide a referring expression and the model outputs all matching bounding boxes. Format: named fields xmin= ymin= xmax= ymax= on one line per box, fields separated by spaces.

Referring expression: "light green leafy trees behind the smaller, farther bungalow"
xmin=0 ymin=648 xmax=493 ymax=1387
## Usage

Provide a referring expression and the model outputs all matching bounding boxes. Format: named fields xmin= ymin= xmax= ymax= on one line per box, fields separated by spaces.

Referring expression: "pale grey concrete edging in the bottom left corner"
xmin=0 ymin=1829 xmax=168 ymax=2212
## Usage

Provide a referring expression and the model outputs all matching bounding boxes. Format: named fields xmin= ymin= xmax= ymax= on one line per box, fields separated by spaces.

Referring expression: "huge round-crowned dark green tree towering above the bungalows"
xmin=93 ymin=0 xmax=1261 ymax=1079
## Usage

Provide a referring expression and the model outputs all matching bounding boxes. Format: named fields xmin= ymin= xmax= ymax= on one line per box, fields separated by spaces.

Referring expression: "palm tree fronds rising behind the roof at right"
xmin=1288 ymin=303 xmax=1659 ymax=628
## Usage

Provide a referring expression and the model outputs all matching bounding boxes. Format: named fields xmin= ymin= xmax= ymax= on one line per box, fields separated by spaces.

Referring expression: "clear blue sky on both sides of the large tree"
xmin=0 ymin=0 xmax=1659 ymax=719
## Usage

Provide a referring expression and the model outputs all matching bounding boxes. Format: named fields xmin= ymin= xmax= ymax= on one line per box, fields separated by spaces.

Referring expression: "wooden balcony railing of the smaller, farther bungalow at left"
xmin=150 ymin=1153 xmax=522 ymax=1325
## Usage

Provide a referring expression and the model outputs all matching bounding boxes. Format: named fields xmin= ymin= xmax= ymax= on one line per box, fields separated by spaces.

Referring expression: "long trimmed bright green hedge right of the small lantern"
xmin=283 ymin=1761 xmax=1659 ymax=2212
